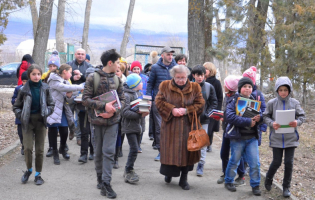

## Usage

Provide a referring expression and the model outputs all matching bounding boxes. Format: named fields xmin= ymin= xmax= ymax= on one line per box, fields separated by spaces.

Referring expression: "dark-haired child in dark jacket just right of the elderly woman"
xmin=191 ymin=65 xmax=218 ymax=176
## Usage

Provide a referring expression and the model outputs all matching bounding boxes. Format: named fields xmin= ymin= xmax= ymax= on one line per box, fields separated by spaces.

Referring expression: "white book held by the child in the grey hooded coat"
xmin=275 ymin=109 xmax=295 ymax=133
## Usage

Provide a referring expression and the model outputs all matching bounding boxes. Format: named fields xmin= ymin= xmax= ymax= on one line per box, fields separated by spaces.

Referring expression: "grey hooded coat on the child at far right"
xmin=263 ymin=77 xmax=305 ymax=148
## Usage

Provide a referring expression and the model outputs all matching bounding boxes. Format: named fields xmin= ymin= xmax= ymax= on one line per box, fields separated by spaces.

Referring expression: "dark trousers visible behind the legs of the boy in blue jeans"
xmin=220 ymin=136 xmax=245 ymax=177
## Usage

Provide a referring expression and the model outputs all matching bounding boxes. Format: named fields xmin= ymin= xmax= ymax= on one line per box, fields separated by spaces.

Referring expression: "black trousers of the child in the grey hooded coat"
xmin=266 ymin=147 xmax=295 ymax=188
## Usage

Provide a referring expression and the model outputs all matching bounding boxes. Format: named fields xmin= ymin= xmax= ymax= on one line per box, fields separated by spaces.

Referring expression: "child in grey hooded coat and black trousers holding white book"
xmin=263 ymin=76 xmax=305 ymax=197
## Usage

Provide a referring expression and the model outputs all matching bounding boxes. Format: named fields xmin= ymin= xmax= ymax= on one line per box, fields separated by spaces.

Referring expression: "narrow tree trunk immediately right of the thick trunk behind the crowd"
xmin=204 ymin=0 xmax=213 ymax=62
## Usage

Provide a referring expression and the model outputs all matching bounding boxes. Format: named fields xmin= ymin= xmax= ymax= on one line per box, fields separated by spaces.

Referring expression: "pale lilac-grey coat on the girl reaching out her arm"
xmin=47 ymin=73 xmax=84 ymax=127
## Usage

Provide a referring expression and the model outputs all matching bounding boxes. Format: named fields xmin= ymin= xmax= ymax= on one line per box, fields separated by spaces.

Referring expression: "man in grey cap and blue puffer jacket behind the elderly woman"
xmin=146 ymin=46 xmax=176 ymax=161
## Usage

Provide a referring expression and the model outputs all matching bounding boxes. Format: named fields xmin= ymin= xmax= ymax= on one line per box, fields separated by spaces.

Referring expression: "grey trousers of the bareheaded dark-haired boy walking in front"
xmin=94 ymin=124 xmax=118 ymax=184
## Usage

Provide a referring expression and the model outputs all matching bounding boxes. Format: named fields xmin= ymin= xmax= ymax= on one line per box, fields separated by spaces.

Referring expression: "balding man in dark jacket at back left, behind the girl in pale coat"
xmin=67 ymin=48 xmax=92 ymax=146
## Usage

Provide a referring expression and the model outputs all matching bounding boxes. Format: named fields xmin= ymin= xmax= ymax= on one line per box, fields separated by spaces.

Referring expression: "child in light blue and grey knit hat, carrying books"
xmin=121 ymin=73 xmax=149 ymax=183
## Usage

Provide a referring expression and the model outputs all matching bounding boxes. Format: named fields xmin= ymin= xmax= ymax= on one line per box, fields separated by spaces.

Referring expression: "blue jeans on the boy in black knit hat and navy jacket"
xmin=224 ymin=137 xmax=260 ymax=188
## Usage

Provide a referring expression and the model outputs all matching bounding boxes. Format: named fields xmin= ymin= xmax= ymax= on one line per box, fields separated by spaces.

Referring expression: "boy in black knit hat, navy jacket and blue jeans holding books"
xmin=224 ymin=77 xmax=262 ymax=196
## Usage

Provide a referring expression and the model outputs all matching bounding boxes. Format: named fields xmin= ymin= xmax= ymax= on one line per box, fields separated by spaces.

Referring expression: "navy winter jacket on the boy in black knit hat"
xmin=224 ymin=93 xmax=263 ymax=139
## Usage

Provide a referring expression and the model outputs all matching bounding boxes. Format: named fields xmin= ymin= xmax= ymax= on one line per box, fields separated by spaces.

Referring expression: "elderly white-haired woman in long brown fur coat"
xmin=155 ymin=65 xmax=205 ymax=190
